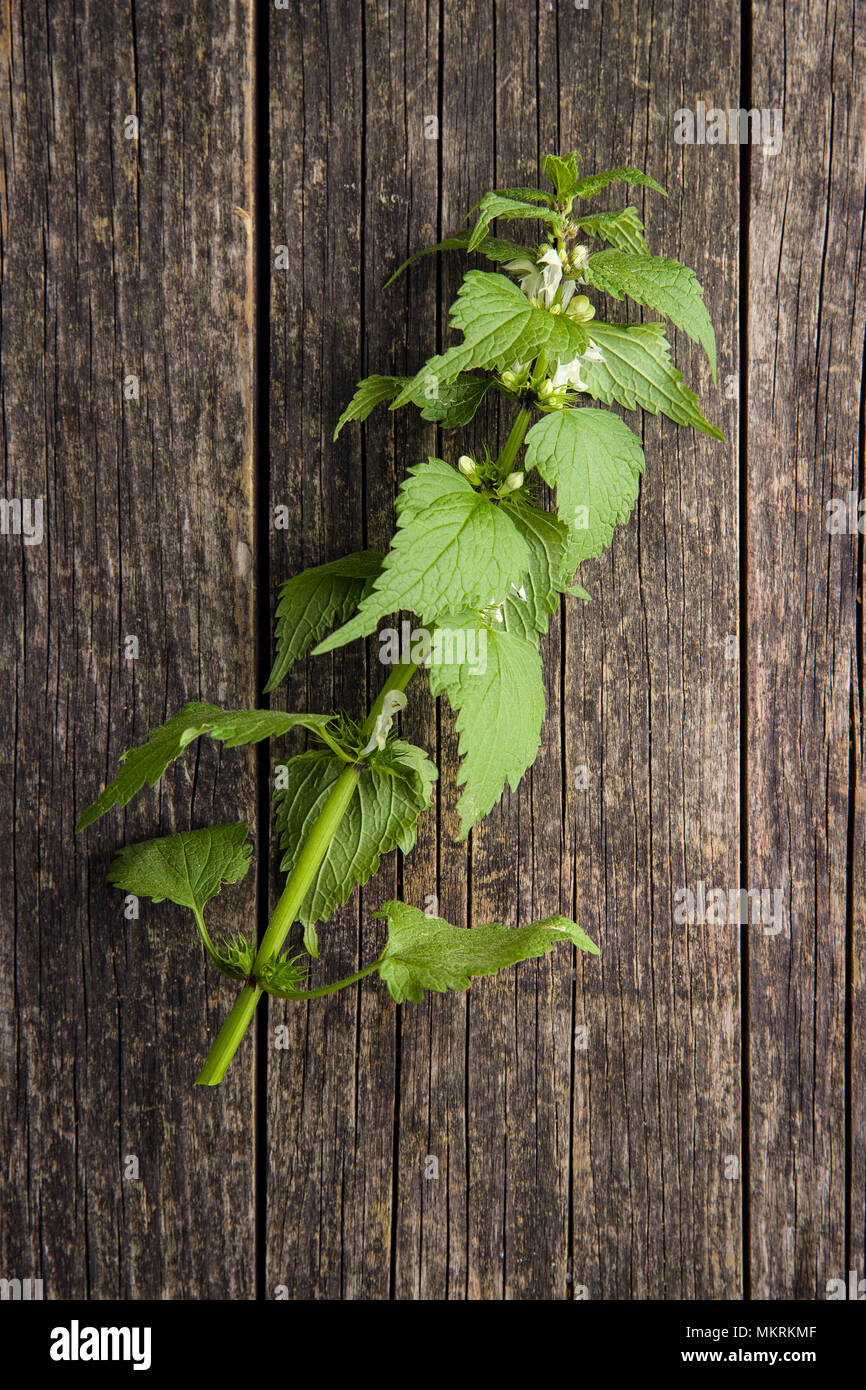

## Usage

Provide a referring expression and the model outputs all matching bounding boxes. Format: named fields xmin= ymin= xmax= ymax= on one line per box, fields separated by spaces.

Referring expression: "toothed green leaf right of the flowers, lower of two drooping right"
xmin=581 ymin=322 xmax=724 ymax=439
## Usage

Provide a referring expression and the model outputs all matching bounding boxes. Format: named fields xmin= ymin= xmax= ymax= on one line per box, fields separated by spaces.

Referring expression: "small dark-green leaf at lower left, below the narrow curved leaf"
xmin=106 ymin=821 xmax=253 ymax=913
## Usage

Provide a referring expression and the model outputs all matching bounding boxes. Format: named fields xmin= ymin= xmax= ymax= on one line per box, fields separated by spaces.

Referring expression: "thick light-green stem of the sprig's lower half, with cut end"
xmin=196 ymin=658 xmax=428 ymax=1086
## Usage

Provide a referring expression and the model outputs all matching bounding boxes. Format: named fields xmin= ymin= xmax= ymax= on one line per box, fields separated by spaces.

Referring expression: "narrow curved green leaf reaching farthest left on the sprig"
xmin=75 ymin=702 xmax=331 ymax=831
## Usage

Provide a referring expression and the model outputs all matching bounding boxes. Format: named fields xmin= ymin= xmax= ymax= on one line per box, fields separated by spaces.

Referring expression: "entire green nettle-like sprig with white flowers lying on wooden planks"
xmin=76 ymin=152 xmax=723 ymax=1084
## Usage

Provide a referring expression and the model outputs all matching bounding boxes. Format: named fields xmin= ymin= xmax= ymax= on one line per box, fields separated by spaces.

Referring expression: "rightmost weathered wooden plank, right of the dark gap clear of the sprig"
xmin=748 ymin=3 xmax=865 ymax=1298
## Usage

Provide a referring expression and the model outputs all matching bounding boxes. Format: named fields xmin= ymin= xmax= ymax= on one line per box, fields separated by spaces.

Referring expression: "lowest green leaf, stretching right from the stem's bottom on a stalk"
xmin=373 ymin=902 xmax=601 ymax=1004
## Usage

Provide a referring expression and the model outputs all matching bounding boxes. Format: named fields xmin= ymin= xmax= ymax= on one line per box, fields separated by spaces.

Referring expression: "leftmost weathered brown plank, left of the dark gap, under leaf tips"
xmin=0 ymin=0 xmax=254 ymax=1298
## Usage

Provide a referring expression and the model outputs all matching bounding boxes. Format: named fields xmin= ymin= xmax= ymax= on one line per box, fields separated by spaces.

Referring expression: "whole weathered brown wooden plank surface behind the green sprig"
xmin=0 ymin=0 xmax=866 ymax=1298
